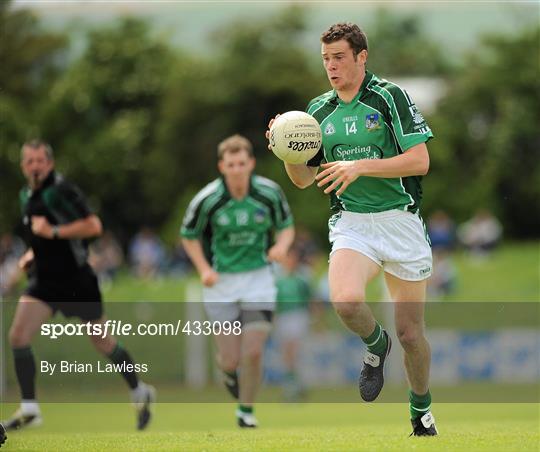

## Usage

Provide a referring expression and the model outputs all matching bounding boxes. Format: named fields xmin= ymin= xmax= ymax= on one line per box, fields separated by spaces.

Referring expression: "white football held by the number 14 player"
xmin=269 ymin=111 xmax=322 ymax=164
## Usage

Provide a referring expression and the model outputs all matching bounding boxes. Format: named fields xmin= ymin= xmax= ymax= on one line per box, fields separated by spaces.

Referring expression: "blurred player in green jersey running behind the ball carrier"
xmin=181 ymin=135 xmax=294 ymax=427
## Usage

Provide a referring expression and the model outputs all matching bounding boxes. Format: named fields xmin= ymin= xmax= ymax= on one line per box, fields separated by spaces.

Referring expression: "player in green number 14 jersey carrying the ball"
xmin=270 ymin=23 xmax=437 ymax=436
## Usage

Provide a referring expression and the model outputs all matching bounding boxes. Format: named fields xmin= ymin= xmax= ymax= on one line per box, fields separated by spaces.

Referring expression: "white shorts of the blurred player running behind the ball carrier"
xmin=203 ymin=266 xmax=277 ymax=321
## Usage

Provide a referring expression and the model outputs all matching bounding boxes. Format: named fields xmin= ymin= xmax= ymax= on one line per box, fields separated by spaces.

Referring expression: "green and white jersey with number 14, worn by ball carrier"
xmin=307 ymin=71 xmax=433 ymax=213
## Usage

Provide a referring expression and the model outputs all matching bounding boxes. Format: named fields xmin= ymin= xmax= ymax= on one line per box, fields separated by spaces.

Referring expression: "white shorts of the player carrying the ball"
xmin=328 ymin=210 xmax=433 ymax=281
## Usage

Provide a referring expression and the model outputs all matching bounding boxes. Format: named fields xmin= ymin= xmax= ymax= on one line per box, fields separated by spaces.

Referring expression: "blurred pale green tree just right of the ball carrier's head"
xmin=368 ymin=8 xmax=451 ymax=77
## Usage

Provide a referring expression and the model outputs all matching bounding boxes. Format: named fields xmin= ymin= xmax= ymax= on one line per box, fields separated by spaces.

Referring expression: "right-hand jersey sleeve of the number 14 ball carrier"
xmin=389 ymin=86 xmax=433 ymax=151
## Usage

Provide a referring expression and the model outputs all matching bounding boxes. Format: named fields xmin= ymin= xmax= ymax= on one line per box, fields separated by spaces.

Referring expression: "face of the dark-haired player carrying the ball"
xmin=322 ymin=39 xmax=367 ymax=91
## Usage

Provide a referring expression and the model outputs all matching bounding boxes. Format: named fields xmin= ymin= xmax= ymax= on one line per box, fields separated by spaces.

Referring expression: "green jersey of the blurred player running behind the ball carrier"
xmin=180 ymin=175 xmax=293 ymax=273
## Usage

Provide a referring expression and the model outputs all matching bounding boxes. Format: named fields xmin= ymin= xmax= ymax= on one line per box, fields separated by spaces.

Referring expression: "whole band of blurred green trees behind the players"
xmin=0 ymin=2 xmax=540 ymax=243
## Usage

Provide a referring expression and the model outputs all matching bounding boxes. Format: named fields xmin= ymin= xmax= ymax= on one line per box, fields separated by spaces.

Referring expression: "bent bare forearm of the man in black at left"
xmin=31 ymin=214 xmax=103 ymax=240
